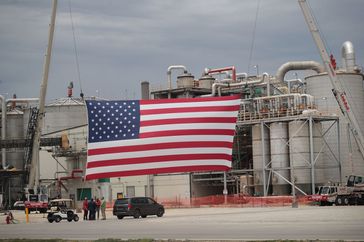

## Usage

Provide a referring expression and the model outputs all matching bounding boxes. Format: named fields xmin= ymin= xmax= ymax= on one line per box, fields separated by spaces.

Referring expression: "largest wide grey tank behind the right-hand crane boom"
xmin=305 ymin=72 xmax=364 ymax=182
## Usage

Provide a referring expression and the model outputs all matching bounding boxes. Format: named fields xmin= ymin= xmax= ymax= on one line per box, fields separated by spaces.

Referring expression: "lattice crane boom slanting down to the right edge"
xmin=298 ymin=0 xmax=364 ymax=161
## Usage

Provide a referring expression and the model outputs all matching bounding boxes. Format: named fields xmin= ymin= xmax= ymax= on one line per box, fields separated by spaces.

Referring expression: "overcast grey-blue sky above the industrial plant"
xmin=0 ymin=0 xmax=364 ymax=100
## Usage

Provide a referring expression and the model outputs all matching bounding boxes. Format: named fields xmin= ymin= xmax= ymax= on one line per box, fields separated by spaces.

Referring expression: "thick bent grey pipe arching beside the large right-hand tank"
xmin=276 ymin=61 xmax=325 ymax=82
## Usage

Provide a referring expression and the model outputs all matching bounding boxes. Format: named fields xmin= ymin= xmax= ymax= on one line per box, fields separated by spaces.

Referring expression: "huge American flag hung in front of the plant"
xmin=86 ymin=96 xmax=240 ymax=180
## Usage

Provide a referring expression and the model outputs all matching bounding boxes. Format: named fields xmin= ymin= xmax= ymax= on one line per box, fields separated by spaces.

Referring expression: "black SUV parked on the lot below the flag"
xmin=112 ymin=197 xmax=164 ymax=219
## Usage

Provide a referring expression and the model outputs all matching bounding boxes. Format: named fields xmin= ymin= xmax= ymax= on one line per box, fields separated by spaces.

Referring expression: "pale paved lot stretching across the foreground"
xmin=0 ymin=206 xmax=364 ymax=241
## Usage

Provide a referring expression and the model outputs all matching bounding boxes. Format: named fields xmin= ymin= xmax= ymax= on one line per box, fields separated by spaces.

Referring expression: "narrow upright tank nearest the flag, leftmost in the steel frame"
xmin=252 ymin=124 xmax=270 ymax=195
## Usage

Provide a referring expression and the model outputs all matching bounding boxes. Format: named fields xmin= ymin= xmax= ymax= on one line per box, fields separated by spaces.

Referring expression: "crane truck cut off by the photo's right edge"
xmin=335 ymin=175 xmax=364 ymax=206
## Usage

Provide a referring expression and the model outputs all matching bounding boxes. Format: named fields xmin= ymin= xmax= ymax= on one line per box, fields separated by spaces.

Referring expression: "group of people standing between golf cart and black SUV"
xmin=82 ymin=197 xmax=106 ymax=220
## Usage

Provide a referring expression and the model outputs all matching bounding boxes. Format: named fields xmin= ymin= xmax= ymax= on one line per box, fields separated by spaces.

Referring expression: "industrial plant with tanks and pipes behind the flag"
xmin=0 ymin=39 xmax=364 ymax=210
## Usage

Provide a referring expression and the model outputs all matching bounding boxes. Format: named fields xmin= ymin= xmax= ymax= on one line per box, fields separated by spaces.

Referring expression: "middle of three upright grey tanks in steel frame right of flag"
xmin=270 ymin=122 xmax=290 ymax=195
